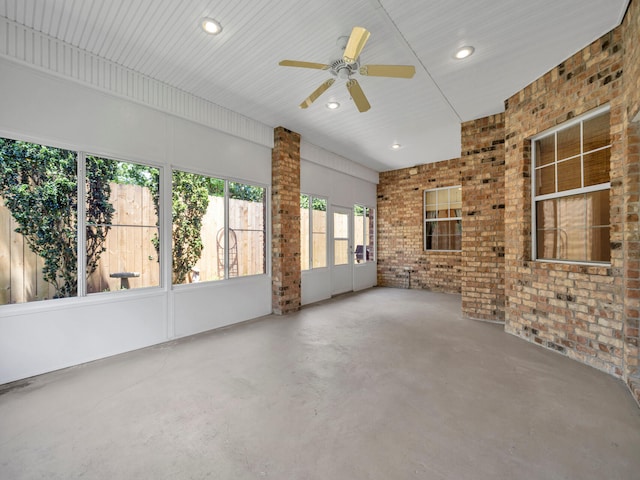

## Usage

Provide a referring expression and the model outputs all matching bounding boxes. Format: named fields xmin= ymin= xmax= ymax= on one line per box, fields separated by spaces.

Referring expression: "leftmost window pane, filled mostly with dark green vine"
xmin=0 ymin=138 xmax=78 ymax=305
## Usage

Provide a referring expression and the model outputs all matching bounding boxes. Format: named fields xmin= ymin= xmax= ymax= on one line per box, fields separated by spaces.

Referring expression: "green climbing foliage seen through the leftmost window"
xmin=0 ymin=138 xmax=114 ymax=297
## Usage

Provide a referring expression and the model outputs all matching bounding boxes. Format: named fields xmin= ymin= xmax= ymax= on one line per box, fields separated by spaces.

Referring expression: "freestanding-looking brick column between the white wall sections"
xmin=271 ymin=127 xmax=301 ymax=315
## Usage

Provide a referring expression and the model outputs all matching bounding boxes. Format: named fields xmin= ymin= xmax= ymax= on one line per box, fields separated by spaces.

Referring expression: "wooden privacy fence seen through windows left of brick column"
xmin=0 ymin=184 xmax=265 ymax=305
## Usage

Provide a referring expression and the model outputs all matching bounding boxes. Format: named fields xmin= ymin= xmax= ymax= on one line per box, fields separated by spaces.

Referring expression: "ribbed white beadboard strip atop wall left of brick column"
xmin=0 ymin=18 xmax=273 ymax=148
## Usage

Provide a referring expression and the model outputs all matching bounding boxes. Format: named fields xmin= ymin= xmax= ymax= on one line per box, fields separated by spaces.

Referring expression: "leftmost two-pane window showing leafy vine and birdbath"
xmin=0 ymin=138 xmax=160 ymax=305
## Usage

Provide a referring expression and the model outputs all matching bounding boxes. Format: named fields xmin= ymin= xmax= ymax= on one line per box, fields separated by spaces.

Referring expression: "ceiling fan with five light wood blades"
xmin=279 ymin=27 xmax=416 ymax=112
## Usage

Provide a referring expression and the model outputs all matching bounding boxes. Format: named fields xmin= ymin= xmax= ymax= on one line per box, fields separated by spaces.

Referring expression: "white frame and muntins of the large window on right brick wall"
xmin=531 ymin=105 xmax=611 ymax=266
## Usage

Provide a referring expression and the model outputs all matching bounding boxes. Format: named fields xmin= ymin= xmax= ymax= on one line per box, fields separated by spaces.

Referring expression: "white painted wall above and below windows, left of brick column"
xmin=0 ymin=58 xmax=271 ymax=384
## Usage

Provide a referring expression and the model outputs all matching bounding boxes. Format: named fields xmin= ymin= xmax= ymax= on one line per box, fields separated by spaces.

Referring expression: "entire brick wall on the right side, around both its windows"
xmin=378 ymin=0 xmax=640 ymax=403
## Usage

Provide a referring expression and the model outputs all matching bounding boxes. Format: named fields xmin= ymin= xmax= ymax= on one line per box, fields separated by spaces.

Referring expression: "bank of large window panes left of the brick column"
xmin=0 ymin=138 xmax=266 ymax=305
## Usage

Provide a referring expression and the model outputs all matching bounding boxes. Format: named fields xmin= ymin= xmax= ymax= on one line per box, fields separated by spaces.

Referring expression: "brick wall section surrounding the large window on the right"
xmin=505 ymin=28 xmax=625 ymax=376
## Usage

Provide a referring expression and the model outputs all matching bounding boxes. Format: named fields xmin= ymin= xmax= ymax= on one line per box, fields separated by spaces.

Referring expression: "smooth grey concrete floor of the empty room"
xmin=0 ymin=288 xmax=640 ymax=480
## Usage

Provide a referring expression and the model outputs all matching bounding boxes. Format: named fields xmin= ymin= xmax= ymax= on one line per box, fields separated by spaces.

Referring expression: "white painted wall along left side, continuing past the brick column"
xmin=0 ymin=55 xmax=378 ymax=384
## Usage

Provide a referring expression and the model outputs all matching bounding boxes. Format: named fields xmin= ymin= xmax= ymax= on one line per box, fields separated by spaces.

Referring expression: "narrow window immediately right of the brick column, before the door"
xmin=300 ymin=194 xmax=327 ymax=270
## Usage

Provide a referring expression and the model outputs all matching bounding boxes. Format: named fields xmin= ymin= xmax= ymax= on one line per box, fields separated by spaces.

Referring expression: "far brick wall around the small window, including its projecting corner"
xmin=378 ymin=114 xmax=504 ymax=321
